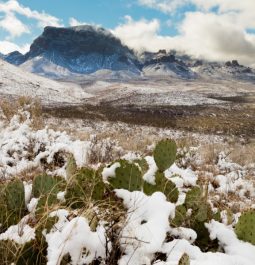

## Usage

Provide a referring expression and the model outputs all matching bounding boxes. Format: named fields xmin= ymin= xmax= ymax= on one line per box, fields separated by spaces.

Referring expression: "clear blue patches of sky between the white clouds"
xmin=0 ymin=0 xmax=189 ymax=45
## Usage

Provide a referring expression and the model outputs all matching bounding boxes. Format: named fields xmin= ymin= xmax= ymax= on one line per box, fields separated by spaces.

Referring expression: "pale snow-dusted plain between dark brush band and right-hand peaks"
xmin=77 ymin=77 xmax=255 ymax=107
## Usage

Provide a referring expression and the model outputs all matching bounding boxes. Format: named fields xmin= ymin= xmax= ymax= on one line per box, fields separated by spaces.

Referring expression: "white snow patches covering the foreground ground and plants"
xmin=0 ymin=107 xmax=255 ymax=265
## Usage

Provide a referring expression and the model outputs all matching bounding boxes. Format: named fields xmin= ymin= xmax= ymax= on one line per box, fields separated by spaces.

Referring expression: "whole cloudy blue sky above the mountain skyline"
xmin=0 ymin=0 xmax=255 ymax=64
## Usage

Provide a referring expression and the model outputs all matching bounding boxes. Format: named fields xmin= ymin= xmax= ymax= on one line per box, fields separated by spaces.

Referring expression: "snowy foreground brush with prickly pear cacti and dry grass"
xmin=0 ymin=99 xmax=255 ymax=265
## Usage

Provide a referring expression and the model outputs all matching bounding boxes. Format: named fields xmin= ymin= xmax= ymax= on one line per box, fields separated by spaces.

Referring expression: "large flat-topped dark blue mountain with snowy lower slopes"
xmin=7 ymin=25 xmax=139 ymax=77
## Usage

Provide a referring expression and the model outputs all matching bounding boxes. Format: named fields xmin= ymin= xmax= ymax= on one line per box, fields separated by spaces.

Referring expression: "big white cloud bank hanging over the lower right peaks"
xmin=112 ymin=12 xmax=255 ymax=64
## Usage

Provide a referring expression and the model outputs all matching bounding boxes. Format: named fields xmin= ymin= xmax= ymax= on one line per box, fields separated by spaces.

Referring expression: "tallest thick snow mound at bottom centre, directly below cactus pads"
xmin=116 ymin=189 xmax=175 ymax=265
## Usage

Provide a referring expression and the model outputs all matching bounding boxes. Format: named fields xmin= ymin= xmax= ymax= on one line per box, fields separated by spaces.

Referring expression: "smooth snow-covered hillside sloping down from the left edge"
xmin=0 ymin=59 xmax=90 ymax=104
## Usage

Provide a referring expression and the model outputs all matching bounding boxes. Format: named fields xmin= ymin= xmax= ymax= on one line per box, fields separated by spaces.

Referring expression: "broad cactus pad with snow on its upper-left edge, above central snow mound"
xmin=108 ymin=160 xmax=142 ymax=191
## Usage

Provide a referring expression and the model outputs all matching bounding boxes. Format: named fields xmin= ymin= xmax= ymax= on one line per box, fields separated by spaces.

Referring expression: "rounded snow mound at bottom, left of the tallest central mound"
xmin=46 ymin=211 xmax=106 ymax=265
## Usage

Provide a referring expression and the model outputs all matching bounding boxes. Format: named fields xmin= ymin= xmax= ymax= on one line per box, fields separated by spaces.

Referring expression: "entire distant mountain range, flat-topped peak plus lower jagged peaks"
xmin=0 ymin=25 xmax=255 ymax=81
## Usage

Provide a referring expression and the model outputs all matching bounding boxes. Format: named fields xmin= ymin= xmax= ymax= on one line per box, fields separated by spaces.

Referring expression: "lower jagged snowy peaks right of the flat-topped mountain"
xmin=140 ymin=50 xmax=255 ymax=81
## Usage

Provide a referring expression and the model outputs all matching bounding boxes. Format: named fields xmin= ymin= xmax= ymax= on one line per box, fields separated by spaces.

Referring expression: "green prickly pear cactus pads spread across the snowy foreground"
xmin=0 ymin=140 xmax=237 ymax=265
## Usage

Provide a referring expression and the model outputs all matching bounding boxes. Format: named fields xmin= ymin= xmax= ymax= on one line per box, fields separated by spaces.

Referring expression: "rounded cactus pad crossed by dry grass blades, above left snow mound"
xmin=65 ymin=168 xmax=105 ymax=208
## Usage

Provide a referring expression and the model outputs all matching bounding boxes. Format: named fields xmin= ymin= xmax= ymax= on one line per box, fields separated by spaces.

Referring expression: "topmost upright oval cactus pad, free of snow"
xmin=153 ymin=139 xmax=177 ymax=172
